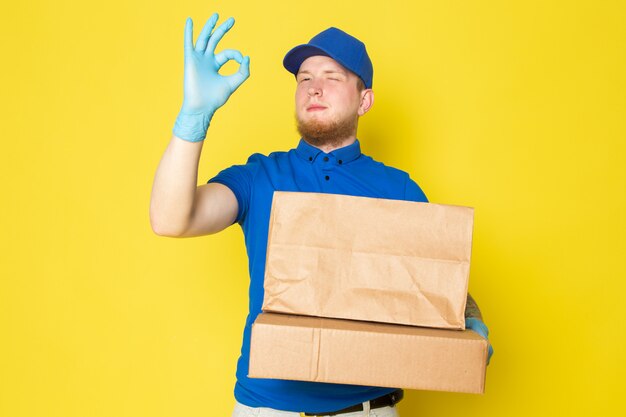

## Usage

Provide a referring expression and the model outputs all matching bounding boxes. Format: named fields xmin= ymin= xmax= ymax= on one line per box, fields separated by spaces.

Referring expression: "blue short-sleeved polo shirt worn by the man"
xmin=209 ymin=140 xmax=427 ymax=412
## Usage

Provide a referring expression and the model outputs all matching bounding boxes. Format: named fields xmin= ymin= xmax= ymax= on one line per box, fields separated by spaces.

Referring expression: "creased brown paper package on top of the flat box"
xmin=263 ymin=192 xmax=474 ymax=329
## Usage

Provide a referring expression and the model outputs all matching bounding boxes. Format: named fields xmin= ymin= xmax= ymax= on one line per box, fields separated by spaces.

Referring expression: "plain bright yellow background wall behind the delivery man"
xmin=0 ymin=0 xmax=626 ymax=417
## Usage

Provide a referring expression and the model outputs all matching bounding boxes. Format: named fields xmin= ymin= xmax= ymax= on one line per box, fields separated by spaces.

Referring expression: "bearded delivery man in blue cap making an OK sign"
xmin=150 ymin=14 xmax=486 ymax=417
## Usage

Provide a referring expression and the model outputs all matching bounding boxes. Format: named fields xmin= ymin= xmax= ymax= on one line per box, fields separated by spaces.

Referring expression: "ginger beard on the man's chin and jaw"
xmin=296 ymin=110 xmax=359 ymax=148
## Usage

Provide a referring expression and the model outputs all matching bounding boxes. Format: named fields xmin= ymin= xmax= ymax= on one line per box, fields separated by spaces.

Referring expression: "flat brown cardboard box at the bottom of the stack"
xmin=248 ymin=313 xmax=488 ymax=394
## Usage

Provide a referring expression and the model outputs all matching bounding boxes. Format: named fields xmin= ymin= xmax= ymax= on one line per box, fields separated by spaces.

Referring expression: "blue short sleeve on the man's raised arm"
xmin=207 ymin=154 xmax=262 ymax=224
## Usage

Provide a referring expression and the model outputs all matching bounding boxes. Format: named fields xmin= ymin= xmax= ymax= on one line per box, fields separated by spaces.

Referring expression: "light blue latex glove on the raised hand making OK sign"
xmin=174 ymin=13 xmax=250 ymax=142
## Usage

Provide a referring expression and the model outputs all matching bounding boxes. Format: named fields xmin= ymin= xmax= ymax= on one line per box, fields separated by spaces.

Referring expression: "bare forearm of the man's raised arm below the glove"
xmin=150 ymin=136 xmax=204 ymax=236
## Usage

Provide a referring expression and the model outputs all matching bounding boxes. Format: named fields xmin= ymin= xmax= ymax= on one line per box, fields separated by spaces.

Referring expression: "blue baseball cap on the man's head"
xmin=283 ymin=28 xmax=374 ymax=88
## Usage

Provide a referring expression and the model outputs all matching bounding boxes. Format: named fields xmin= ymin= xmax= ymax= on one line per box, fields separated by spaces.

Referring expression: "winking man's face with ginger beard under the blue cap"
xmin=296 ymin=55 xmax=367 ymax=146
